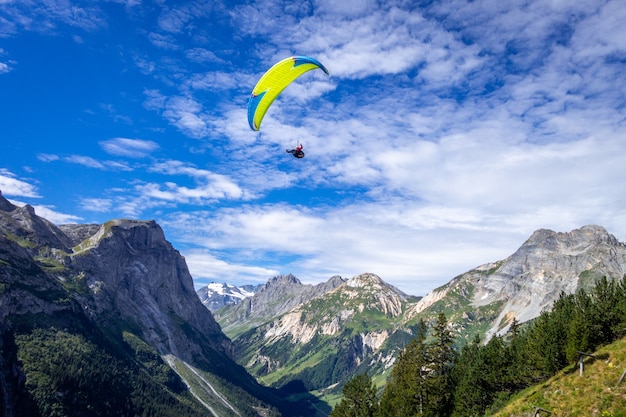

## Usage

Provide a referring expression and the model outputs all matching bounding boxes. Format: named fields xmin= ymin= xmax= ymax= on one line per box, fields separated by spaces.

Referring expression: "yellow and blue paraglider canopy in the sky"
xmin=248 ymin=56 xmax=328 ymax=130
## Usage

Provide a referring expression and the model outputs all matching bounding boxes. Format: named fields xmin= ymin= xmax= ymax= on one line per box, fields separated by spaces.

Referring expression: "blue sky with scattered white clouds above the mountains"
xmin=0 ymin=0 xmax=626 ymax=295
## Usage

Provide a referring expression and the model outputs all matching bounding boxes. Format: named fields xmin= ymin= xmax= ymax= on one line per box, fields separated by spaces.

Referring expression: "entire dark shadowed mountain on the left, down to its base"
xmin=0 ymin=194 xmax=322 ymax=416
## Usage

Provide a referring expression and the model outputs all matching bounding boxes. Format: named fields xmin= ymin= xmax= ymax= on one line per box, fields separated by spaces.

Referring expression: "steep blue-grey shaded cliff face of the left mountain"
xmin=71 ymin=220 xmax=232 ymax=361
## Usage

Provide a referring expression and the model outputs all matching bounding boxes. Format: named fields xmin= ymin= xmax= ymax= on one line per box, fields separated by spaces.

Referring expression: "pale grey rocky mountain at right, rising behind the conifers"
xmin=406 ymin=225 xmax=626 ymax=338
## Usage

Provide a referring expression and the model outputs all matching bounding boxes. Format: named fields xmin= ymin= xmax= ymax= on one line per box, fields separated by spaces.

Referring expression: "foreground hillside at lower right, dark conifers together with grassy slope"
xmin=331 ymin=278 xmax=626 ymax=417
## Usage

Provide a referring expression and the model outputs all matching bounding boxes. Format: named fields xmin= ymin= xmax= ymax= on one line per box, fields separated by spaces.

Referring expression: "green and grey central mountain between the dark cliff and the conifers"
xmin=216 ymin=273 xmax=419 ymax=393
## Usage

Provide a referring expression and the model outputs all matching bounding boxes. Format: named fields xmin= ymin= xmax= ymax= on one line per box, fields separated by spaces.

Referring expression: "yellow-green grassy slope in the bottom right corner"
xmin=492 ymin=338 xmax=626 ymax=417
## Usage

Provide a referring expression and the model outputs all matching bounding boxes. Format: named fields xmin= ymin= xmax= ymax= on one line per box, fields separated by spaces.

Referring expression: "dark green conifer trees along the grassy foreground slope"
xmin=331 ymin=276 xmax=626 ymax=417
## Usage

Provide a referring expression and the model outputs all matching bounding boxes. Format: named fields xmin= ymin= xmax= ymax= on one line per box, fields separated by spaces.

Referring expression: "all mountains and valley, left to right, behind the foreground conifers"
xmin=0 ymin=187 xmax=626 ymax=417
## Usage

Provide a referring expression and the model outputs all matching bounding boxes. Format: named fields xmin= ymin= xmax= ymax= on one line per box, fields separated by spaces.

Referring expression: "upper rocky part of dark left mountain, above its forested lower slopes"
xmin=0 ymin=190 xmax=233 ymax=363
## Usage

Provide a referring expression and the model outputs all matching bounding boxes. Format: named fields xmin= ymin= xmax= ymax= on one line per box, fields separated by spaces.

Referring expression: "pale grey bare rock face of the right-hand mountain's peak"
xmin=480 ymin=226 xmax=626 ymax=334
